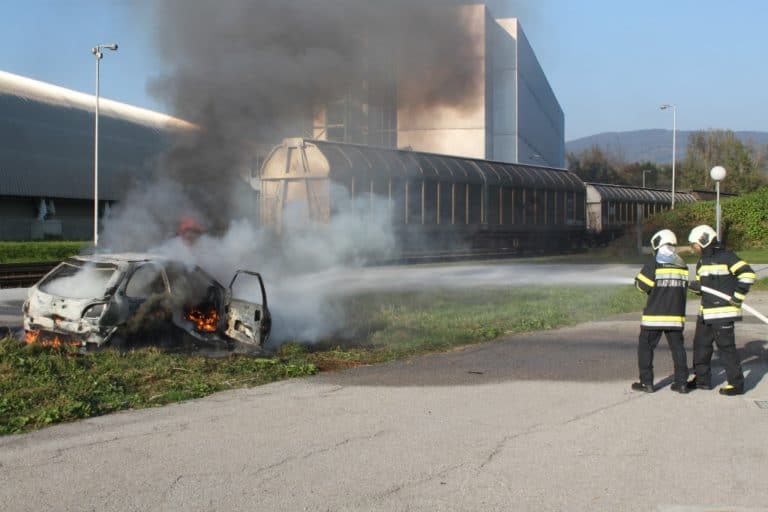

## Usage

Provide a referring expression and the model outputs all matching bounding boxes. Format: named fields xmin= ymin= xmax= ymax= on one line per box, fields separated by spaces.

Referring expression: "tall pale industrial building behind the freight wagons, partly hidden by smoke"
xmin=313 ymin=4 xmax=565 ymax=167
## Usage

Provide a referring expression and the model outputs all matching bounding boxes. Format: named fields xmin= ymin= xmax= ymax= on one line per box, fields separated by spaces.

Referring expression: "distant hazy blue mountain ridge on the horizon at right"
xmin=565 ymin=130 xmax=768 ymax=164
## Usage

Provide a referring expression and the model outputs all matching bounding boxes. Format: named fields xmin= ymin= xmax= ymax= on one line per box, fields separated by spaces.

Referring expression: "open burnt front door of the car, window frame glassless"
xmin=226 ymin=270 xmax=272 ymax=346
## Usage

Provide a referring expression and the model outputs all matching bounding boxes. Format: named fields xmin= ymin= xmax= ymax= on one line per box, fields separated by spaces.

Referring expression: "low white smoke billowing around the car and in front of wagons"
xmin=100 ymin=181 xmax=396 ymax=342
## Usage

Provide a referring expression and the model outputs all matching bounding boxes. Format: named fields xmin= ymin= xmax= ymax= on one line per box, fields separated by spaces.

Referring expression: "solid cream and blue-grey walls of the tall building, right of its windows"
xmin=397 ymin=5 xmax=565 ymax=167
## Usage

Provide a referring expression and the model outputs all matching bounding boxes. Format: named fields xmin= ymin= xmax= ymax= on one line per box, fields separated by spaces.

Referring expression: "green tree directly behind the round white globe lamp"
xmin=677 ymin=130 xmax=768 ymax=194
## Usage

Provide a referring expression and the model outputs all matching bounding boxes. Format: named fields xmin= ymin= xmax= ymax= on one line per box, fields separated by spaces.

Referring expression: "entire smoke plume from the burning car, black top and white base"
xmin=102 ymin=0 xmax=481 ymax=341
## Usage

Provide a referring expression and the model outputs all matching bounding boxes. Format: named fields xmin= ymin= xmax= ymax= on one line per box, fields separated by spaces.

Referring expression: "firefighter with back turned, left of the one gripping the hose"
xmin=632 ymin=229 xmax=688 ymax=393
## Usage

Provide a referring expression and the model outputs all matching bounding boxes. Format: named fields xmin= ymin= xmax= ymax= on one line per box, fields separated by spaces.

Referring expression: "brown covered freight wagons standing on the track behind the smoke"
xmin=260 ymin=139 xmax=697 ymax=255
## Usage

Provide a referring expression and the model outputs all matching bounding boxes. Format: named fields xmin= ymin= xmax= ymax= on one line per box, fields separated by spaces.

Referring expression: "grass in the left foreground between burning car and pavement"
xmin=0 ymin=338 xmax=317 ymax=434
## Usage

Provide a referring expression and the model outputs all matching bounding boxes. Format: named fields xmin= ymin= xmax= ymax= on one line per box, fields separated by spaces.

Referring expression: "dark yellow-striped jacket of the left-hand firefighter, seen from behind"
xmin=635 ymin=258 xmax=688 ymax=331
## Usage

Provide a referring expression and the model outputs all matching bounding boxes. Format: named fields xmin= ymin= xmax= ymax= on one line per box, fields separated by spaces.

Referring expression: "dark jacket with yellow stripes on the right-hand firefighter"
xmin=691 ymin=246 xmax=756 ymax=323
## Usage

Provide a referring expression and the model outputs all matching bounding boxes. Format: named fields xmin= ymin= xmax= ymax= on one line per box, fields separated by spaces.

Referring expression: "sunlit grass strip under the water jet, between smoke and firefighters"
xmin=311 ymin=286 xmax=644 ymax=369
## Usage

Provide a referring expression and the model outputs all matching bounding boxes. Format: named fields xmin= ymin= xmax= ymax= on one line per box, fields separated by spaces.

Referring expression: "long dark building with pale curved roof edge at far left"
xmin=0 ymin=72 xmax=192 ymax=240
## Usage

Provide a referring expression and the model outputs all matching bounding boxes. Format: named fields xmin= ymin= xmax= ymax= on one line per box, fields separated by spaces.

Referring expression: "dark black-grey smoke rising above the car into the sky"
xmin=140 ymin=0 xmax=481 ymax=228
